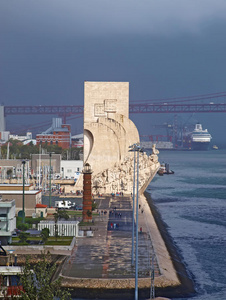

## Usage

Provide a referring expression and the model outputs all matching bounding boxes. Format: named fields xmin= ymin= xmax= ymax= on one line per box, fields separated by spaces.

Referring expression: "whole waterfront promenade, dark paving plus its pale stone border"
xmin=61 ymin=196 xmax=180 ymax=295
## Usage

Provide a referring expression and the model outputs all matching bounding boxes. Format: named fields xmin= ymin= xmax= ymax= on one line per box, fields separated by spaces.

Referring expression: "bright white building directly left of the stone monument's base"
xmin=61 ymin=160 xmax=83 ymax=180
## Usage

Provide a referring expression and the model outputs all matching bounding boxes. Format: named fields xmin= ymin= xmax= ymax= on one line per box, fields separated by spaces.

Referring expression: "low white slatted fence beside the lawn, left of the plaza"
xmin=38 ymin=221 xmax=79 ymax=237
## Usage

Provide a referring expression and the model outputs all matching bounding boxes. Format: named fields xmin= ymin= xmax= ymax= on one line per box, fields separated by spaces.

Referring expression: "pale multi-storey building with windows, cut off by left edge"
xmin=0 ymin=199 xmax=16 ymax=245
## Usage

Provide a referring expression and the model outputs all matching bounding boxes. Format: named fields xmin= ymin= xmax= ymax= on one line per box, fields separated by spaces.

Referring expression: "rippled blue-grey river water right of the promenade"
xmin=149 ymin=150 xmax=226 ymax=300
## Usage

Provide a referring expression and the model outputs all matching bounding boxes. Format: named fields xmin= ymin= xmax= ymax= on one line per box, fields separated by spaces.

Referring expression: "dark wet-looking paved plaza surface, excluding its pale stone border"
xmin=62 ymin=196 xmax=160 ymax=279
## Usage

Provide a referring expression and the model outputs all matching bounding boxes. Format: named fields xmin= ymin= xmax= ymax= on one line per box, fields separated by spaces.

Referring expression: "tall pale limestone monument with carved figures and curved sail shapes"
xmin=76 ymin=81 xmax=159 ymax=194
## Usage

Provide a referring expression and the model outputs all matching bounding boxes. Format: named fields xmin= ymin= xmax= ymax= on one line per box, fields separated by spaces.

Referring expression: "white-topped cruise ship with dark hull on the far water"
xmin=191 ymin=123 xmax=212 ymax=150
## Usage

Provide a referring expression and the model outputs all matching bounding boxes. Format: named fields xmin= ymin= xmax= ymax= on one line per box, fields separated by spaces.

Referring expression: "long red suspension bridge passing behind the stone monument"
xmin=4 ymin=92 xmax=226 ymax=123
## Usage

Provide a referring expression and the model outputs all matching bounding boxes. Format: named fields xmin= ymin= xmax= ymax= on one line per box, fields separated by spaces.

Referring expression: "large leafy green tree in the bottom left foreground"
xmin=20 ymin=253 xmax=71 ymax=300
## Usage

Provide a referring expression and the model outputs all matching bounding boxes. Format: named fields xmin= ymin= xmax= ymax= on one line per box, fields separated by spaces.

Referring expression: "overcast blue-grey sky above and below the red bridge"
xmin=0 ymin=0 xmax=226 ymax=143
